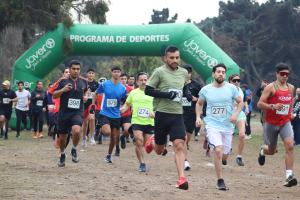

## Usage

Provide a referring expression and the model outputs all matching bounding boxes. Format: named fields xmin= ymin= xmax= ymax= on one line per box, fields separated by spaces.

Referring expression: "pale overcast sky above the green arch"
xmin=106 ymin=0 xmax=267 ymax=25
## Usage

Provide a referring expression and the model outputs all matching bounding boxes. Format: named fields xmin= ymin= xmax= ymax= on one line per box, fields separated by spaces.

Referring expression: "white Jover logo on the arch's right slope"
xmin=183 ymin=40 xmax=218 ymax=68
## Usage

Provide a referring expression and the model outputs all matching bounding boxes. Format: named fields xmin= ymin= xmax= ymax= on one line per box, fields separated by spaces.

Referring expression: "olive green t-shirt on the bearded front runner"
xmin=146 ymin=65 xmax=188 ymax=114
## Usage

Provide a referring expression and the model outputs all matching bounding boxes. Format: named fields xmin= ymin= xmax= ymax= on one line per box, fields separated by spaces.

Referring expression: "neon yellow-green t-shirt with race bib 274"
xmin=126 ymin=88 xmax=154 ymax=126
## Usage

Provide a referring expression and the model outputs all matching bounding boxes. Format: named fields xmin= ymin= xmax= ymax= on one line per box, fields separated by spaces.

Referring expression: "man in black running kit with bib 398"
xmin=53 ymin=60 xmax=88 ymax=167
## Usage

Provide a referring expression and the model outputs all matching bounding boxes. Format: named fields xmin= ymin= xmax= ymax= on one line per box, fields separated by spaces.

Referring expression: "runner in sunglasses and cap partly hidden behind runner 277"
xmin=228 ymin=74 xmax=249 ymax=166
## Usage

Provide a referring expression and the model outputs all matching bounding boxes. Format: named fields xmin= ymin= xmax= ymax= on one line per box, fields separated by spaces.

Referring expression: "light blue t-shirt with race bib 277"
xmin=199 ymin=82 xmax=240 ymax=131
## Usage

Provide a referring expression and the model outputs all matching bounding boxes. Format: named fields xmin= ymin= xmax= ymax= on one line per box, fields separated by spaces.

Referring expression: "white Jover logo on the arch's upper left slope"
xmin=26 ymin=38 xmax=55 ymax=70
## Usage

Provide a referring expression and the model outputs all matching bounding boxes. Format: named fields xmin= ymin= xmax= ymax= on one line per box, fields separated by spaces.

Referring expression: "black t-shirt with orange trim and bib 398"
xmin=54 ymin=76 xmax=88 ymax=120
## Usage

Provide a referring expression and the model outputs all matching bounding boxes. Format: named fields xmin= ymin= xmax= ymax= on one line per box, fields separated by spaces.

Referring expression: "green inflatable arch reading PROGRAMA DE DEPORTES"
xmin=10 ymin=23 xmax=239 ymax=129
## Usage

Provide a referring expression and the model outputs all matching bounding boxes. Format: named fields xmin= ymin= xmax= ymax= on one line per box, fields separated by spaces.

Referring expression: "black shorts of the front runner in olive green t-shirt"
xmin=154 ymin=111 xmax=186 ymax=145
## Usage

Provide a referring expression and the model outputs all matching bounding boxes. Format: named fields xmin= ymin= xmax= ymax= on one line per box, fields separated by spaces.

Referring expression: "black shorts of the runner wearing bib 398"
xmin=58 ymin=114 xmax=83 ymax=134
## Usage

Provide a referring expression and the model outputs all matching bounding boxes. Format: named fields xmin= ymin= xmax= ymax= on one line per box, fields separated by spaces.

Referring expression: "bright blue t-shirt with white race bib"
xmin=96 ymin=80 xmax=127 ymax=118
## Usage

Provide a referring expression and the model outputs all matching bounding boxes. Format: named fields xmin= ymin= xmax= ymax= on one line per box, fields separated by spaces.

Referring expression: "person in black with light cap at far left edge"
xmin=0 ymin=80 xmax=18 ymax=140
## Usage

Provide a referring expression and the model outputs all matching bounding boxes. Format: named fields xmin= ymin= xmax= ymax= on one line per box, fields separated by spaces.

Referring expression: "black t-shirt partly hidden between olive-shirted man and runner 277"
xmin=182 ymin=80 xmax=201 ymax=115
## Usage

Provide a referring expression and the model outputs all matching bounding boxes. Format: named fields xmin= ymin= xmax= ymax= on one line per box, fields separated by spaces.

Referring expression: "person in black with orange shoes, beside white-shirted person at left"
xmin=30 ymin=80 xmax=48 ymax=139
